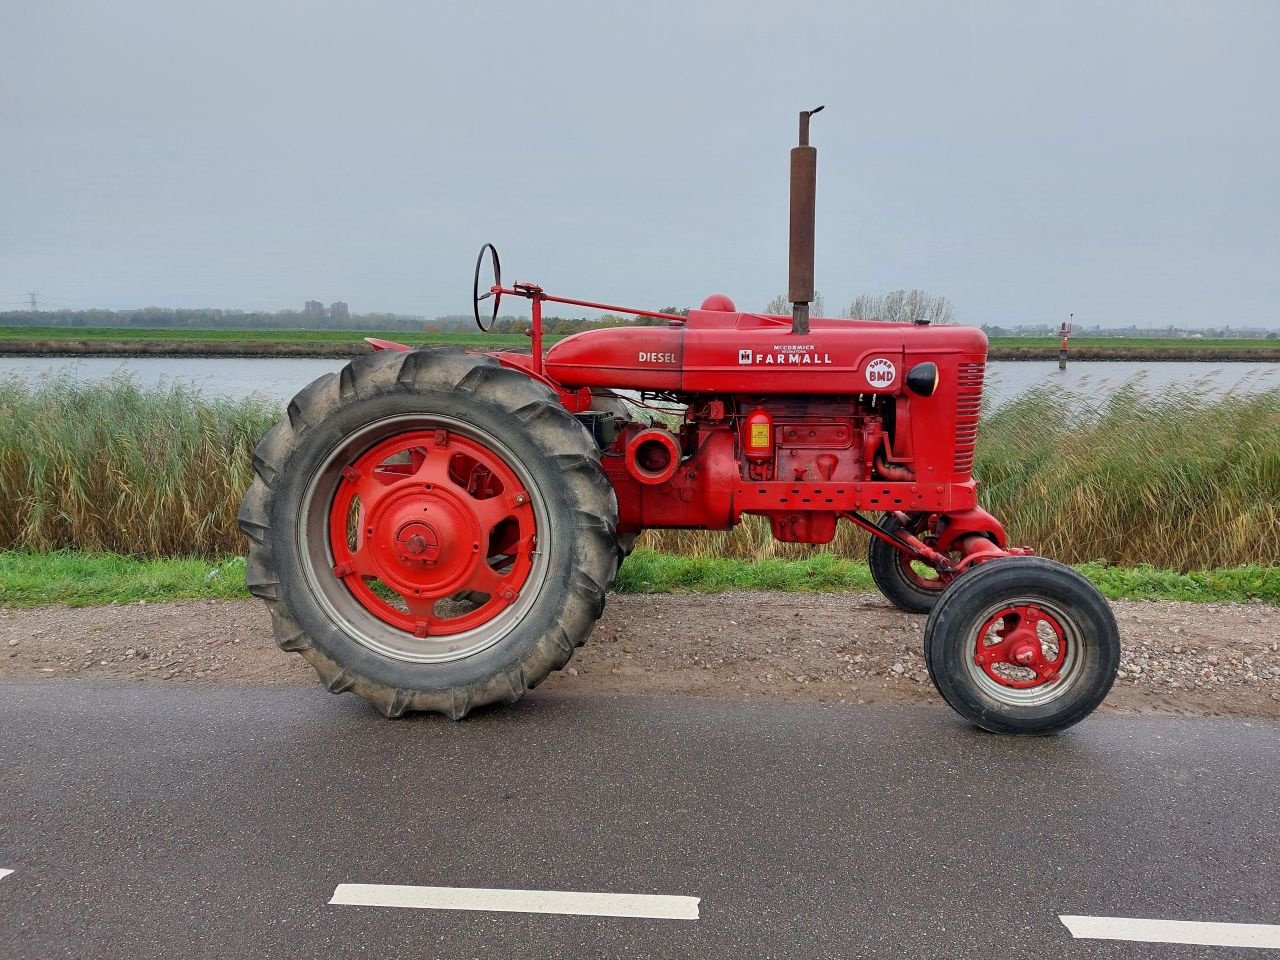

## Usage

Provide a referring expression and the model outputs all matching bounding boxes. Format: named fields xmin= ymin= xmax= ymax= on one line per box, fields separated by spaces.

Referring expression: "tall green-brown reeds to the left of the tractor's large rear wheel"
xmin=0 ymin=379 xmax=280 ymax=557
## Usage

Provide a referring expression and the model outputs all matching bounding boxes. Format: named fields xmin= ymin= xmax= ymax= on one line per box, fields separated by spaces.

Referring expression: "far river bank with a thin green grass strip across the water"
xmin=0 ymin=343 xmax=1280 ymax=364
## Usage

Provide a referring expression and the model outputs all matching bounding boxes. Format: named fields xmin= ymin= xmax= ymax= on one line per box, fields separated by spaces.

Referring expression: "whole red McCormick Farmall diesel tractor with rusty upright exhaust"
xmin=239 ymin=108 xmax=1120 ymax=733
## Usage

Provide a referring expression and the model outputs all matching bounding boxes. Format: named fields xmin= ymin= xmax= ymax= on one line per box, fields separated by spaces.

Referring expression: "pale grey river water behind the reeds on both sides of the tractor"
xmin=0 ymin=357 xmax=1280 ymax=406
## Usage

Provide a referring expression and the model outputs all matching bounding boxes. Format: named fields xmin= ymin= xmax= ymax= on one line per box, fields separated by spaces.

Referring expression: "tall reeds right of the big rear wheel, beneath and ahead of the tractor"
xmin=643 ymin=384 xmax=1280 ymax=571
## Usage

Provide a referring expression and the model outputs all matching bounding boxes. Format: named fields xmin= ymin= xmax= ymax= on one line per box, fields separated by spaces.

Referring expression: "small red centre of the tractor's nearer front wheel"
xmin=973 ymin=603 xmax=1068 ymax=690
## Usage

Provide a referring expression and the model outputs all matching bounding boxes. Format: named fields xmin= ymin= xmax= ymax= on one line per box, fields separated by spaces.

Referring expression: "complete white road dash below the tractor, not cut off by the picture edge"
xmin=329 ymin=883 xmax=698 ymax=920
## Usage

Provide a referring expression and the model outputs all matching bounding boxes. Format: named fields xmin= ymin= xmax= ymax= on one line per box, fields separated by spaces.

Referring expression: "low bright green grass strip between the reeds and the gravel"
xmin=0 ymin=549 xmax=1280 ymax=607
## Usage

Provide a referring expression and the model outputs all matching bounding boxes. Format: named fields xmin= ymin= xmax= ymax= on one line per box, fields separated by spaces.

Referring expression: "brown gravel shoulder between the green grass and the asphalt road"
xmin=0 ymin=591 xmax=1280 ymax=718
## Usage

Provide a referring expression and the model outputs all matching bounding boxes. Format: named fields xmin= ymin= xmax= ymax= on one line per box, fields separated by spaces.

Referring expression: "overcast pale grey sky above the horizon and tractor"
xmin=0 ymin=0 xmax=1280 ymax=325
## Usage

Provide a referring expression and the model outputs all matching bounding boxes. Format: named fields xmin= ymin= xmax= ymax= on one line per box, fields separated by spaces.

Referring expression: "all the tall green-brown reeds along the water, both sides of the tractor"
xmin=0 ymin=380 xmax=1280 ymax=571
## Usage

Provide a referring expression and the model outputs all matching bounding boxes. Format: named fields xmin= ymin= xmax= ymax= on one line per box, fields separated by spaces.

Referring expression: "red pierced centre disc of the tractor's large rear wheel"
xmin=329 ymin=429 xmax=538 ymax=637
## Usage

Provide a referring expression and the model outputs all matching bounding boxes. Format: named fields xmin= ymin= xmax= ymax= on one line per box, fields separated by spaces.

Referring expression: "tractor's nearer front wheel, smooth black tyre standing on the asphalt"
xmin=924 ymin=557 xmax=1120 ymax=735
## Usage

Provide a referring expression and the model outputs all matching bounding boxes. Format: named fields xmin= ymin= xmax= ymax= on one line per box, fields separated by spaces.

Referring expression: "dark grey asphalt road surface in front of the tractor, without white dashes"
xmin=0 ymin=682 xmax=1280 ymax=960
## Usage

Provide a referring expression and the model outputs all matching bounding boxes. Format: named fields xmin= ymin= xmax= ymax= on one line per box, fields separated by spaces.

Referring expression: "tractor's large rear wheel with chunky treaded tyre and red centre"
xmin=239 ymin=349 xmax=617 ymax=718
